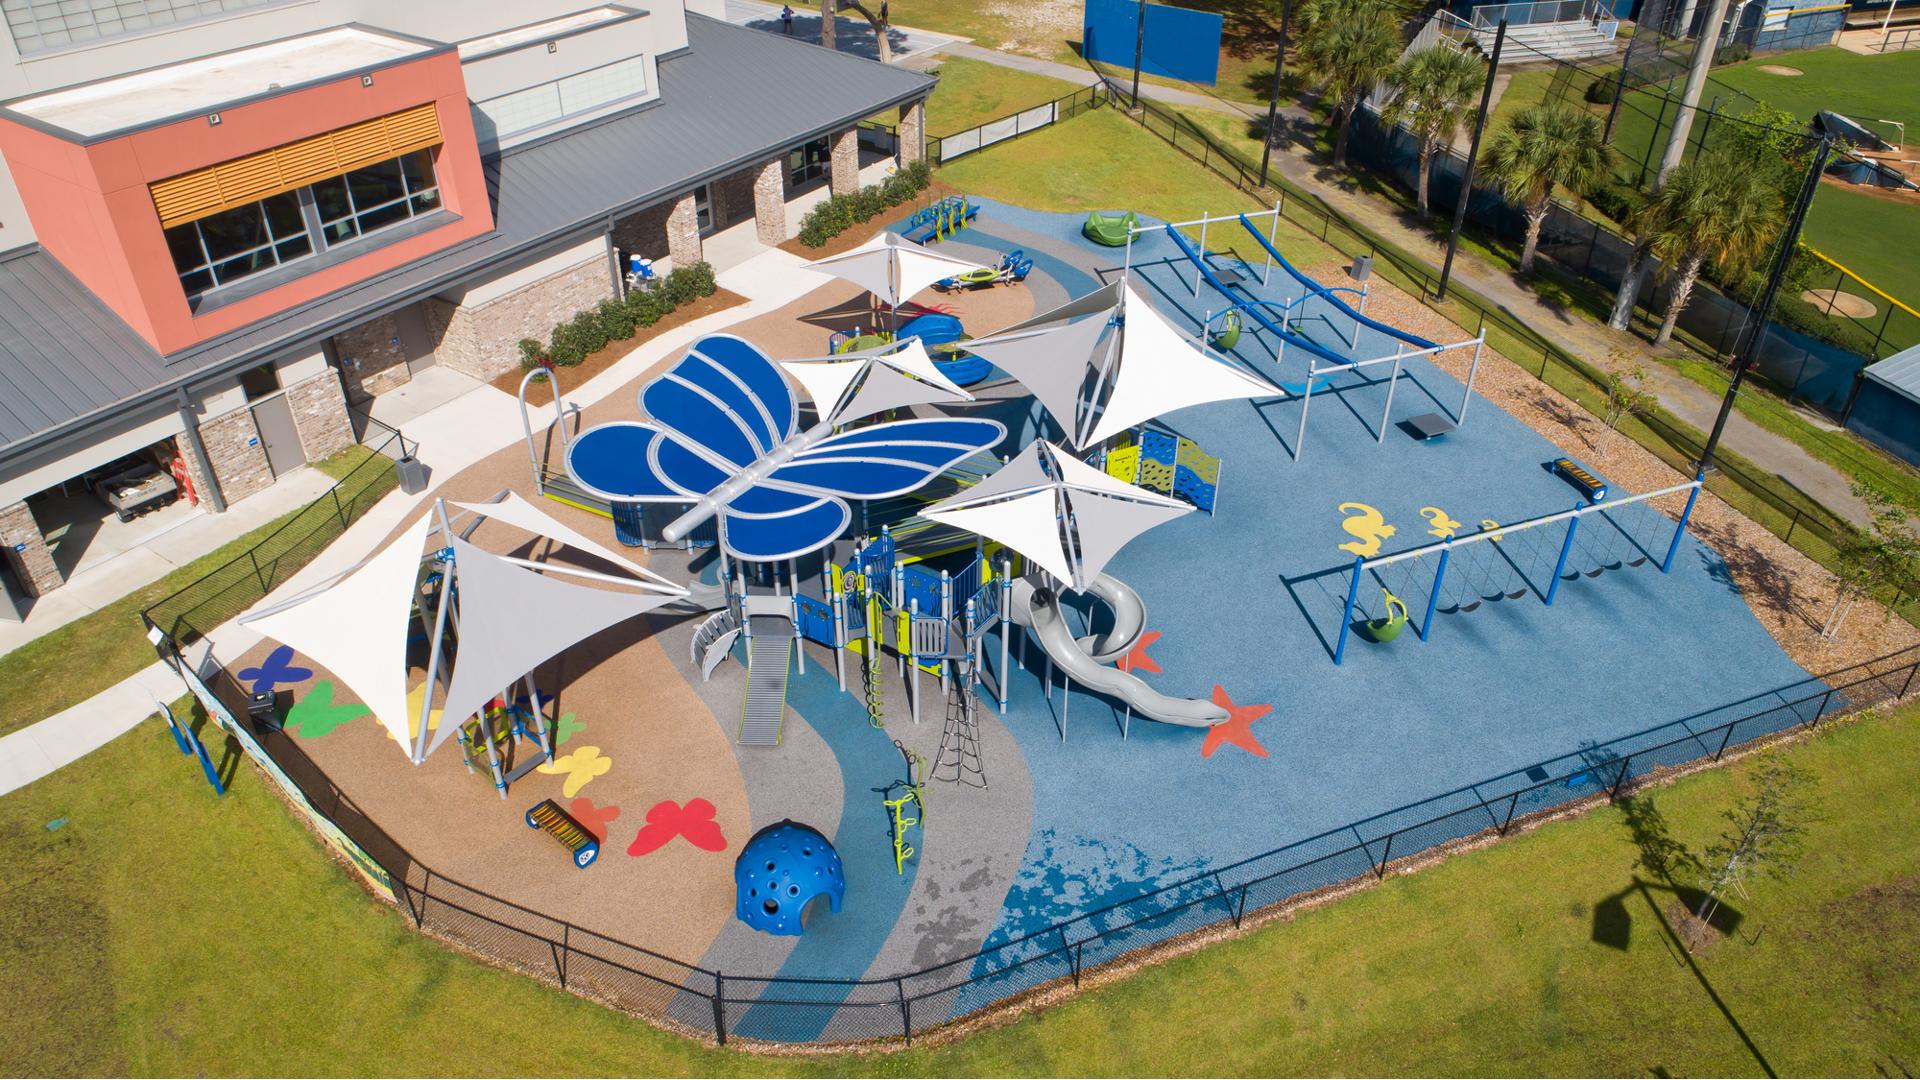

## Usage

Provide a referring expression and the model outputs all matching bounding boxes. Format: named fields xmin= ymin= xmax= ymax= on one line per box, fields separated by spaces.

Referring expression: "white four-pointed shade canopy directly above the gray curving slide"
xmin=922 ymin=440 xmax=1192 ymax=590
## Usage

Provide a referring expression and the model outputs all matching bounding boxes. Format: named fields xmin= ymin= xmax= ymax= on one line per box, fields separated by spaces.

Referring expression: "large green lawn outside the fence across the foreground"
xmin=0 ymin=684 xmax=1920 ymax=1076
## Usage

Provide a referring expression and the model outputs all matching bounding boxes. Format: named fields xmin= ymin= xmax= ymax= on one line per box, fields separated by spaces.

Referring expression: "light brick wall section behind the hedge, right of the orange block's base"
xmin=426 ymin=256 xmax=612 ymax=379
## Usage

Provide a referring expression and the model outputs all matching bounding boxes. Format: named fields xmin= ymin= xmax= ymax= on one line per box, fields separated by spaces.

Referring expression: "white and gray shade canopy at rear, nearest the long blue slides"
xmin=966 ymin=282 xmax=1283 ymax=448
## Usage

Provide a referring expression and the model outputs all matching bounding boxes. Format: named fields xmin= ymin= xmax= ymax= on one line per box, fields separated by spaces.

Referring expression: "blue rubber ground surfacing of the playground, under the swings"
xmin=683 ymin=202 xmax=1809 ymax=1038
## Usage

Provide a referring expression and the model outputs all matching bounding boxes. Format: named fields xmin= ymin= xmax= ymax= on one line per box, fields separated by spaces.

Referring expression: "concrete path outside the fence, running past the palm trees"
xmin=947 ymin=44 xmax=1866 ymax=523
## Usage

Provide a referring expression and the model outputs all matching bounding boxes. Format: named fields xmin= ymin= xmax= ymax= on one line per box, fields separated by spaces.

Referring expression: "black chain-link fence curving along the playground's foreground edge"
xmin=161 ymin=614 xmax=1920 ymax=1043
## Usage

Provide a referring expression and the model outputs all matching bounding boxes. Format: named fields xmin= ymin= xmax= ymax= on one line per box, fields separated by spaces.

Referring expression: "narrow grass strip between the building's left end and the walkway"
xmin=0 ymin=446 xmax=394 ymax=734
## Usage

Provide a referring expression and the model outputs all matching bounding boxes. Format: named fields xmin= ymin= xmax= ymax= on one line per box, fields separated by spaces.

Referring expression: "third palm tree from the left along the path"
xmin=1480 ymin=106 xmax=1613 ymax=275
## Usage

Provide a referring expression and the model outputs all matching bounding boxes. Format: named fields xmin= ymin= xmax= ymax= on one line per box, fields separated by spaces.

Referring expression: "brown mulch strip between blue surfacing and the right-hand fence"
xmin=1308 ymin=263 xmax=1920 ymax=671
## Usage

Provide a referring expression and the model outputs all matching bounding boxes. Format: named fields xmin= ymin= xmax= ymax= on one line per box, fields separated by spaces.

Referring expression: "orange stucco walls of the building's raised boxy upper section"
xmin=0 ymin=52 xmax=493 ymax=354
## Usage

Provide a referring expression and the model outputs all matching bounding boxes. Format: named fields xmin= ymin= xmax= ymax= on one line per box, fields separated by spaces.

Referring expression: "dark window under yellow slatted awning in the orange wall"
xmin=167 ymin=150 xmax=440 ymax=296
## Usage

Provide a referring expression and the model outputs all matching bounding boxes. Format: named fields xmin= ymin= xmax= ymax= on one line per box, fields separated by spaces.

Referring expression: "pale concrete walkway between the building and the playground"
xmin=0 ymin=248 xmax=822 ymax=796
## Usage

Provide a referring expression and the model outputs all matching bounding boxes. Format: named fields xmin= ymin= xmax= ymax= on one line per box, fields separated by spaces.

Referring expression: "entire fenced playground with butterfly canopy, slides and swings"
xmin=221 ymin=191 xmax=1807 ymax=1042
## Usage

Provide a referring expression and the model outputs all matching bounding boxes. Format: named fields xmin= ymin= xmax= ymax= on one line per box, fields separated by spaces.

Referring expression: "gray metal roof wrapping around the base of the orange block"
xmin=0 ymin=12 xmax=933 ymax=461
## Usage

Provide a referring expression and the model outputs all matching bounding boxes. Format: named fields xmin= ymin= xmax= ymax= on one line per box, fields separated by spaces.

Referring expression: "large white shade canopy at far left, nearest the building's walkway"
xmin=246 ymin=494 xmax=687 ymax=763
